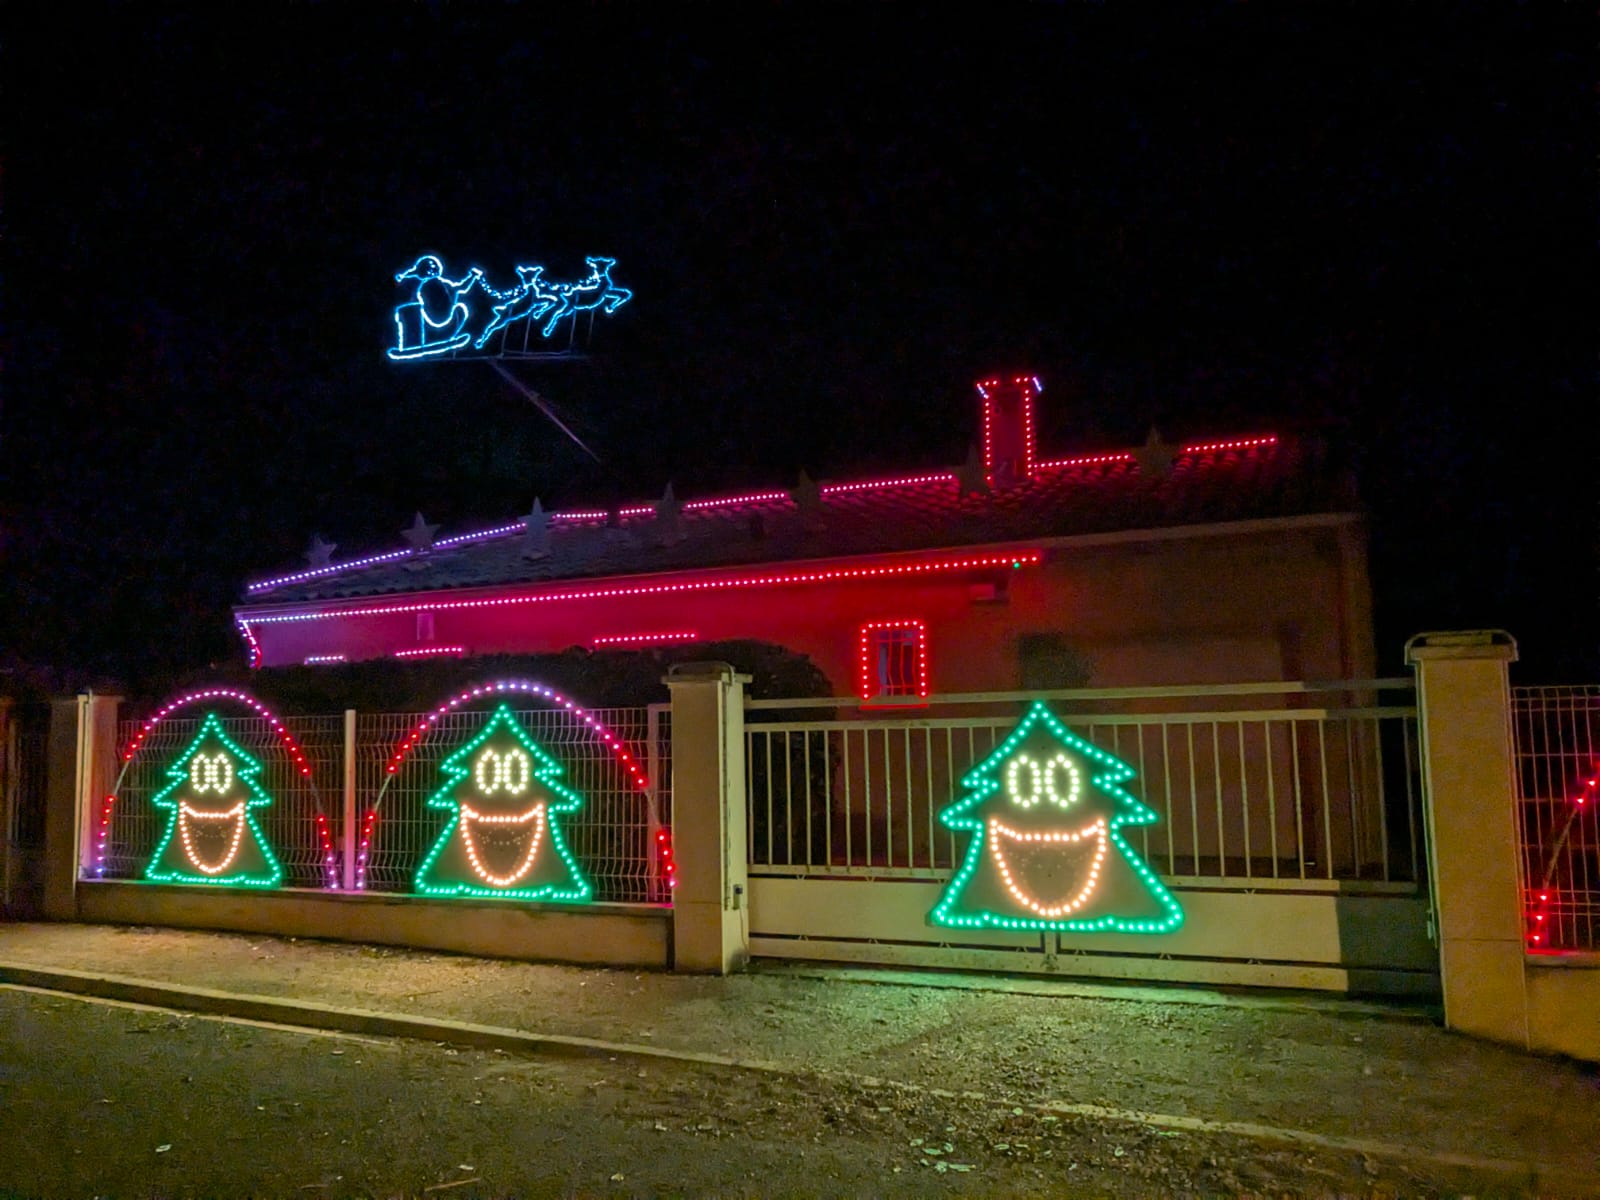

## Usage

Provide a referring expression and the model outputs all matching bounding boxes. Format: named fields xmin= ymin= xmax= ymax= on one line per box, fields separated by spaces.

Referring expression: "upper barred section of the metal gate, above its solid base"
xmin=746 ymin=680 xmax=1422 ymax=883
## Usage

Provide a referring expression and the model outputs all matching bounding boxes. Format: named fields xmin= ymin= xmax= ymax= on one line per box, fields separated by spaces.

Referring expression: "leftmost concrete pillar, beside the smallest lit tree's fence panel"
xmin=43 ymin=693 xmax=122 ymax=920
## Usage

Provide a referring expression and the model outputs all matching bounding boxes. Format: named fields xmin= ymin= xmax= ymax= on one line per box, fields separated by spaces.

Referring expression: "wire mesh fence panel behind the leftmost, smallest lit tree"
xmin=99 ymin=714 xmax=344 ymax=888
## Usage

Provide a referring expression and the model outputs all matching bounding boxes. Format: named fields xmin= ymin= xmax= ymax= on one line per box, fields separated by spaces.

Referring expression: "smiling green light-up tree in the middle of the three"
xmin=416 ymin=704 xmax=592 ymax=902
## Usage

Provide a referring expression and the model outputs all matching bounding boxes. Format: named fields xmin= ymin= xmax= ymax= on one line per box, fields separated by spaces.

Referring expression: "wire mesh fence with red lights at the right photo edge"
xmin=1512 ymin=685 xmax=1600 ymax=952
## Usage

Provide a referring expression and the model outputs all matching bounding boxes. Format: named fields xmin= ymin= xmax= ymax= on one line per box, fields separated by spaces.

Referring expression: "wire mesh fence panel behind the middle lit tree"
xmin=355 ymin=707 xmax=666 ymax=904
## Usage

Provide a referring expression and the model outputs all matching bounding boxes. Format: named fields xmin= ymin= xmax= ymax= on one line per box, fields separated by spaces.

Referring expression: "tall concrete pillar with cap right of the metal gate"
xmin=1406 ymin=630 xmax=1528 ymax=1046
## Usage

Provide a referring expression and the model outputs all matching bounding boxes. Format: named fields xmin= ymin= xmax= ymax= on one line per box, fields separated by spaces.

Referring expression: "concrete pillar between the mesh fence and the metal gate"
xmin=666 ymin=662 xmax=750 ymax=974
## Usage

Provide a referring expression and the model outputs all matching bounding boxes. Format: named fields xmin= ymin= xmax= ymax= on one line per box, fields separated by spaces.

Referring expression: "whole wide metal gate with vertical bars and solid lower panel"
xmin=746 ymin=678 xmax=1437 ymax=990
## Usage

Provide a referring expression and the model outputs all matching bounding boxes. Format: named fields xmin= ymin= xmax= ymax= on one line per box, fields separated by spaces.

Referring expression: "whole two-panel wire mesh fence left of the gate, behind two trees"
xmin=98 ymin=706 xmax=670 ymax=902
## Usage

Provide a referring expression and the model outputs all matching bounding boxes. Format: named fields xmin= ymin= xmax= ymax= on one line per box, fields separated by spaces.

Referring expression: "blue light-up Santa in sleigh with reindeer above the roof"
xmin=387 ymin=254 xmax=634 ymax=362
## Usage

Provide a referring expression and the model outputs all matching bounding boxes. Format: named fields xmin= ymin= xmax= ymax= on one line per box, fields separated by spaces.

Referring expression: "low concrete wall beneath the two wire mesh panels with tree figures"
xmin=75 ymin=882 xmax=672 ymax=970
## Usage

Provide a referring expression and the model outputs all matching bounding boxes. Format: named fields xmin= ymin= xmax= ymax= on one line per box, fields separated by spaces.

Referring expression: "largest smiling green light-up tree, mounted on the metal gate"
xmin=930 ymin=701 xmax=1184 ymax=933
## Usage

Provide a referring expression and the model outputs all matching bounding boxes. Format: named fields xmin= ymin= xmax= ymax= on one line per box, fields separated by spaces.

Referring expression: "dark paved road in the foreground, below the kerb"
xmin=0 ymin=987 xmax=1587 ymax=1198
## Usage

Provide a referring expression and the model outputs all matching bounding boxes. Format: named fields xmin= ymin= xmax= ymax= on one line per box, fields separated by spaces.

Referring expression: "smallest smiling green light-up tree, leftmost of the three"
xmin=144 ymin=712 xmax=283 ymax=888
